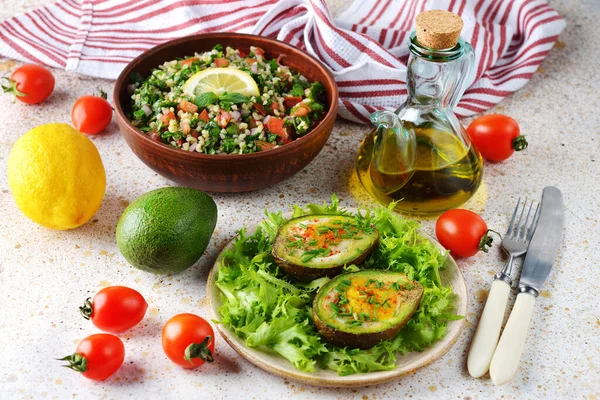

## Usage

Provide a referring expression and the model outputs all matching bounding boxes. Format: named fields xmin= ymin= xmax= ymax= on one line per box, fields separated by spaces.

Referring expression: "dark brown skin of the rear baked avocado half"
xmin=271 ymin=215 xmax=379 ymax=282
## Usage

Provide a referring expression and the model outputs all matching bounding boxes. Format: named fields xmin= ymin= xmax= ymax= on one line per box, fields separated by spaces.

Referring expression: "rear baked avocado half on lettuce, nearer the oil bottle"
xmin=272 ymin=215 xmax=379 ymax=281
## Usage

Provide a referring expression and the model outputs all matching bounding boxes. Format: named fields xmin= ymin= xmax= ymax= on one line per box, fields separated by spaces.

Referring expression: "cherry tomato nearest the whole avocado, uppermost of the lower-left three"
xmin=79 ymin=286 xmax=148 ymax=333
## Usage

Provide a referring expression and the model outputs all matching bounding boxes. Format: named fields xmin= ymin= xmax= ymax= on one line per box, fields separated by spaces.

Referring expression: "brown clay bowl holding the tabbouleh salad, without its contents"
xmin=113 ymin=33 xmax=338 ymax=192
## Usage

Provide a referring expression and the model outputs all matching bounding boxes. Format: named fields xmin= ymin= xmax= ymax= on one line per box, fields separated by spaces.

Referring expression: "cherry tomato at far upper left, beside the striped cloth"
xmin=2 ymin=64 xmax=54 ymax=104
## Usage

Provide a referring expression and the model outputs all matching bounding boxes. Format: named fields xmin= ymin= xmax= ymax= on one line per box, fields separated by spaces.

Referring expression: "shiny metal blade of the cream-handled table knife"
xmin=519 ymin=186 xmax=564 ymax=297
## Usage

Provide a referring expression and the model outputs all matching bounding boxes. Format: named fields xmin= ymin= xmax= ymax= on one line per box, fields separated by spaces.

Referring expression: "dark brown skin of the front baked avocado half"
xmin=312 ymin=270 xmax=423 ymax=349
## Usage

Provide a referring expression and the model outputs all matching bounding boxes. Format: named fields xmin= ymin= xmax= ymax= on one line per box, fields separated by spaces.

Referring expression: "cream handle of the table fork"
xmin=467 ymin=279 xmax=510 ymax=378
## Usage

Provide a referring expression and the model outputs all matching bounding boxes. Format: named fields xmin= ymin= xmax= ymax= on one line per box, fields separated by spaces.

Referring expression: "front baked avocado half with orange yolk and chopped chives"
xmin=312 ymin=270 xmax=423 ymax=349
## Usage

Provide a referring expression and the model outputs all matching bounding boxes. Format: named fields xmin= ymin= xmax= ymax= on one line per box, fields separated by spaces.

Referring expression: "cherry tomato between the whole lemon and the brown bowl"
xmin=71 ymin=94 xmax=112 ymax=135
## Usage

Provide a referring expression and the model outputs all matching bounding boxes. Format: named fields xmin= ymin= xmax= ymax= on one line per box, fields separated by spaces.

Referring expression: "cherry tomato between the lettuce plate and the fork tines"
xmin=435 ymin=209 xmax=492 ymax=257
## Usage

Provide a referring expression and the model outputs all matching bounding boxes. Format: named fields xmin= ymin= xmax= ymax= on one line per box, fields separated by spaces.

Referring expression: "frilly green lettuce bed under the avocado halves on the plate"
xmin=216 ymin=195 xmax=462 ymax=375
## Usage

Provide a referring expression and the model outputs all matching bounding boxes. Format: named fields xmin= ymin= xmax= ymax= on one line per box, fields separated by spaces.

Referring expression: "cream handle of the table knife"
xmin=490 ymin=292 xmax=535 ymax=385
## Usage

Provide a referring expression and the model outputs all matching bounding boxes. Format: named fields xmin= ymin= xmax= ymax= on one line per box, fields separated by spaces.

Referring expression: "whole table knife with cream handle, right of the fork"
xmin=490 ymin=186 xmax=564 ymax=385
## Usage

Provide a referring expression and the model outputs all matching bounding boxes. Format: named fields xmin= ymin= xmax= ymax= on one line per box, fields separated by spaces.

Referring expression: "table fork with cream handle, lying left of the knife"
xmin=467 ymin=198 xmax=540 ymax=378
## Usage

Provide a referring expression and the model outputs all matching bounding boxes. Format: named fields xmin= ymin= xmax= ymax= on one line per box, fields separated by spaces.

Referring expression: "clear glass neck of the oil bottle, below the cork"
xmin=407 ymin=32 xmax=472 ymax=108
